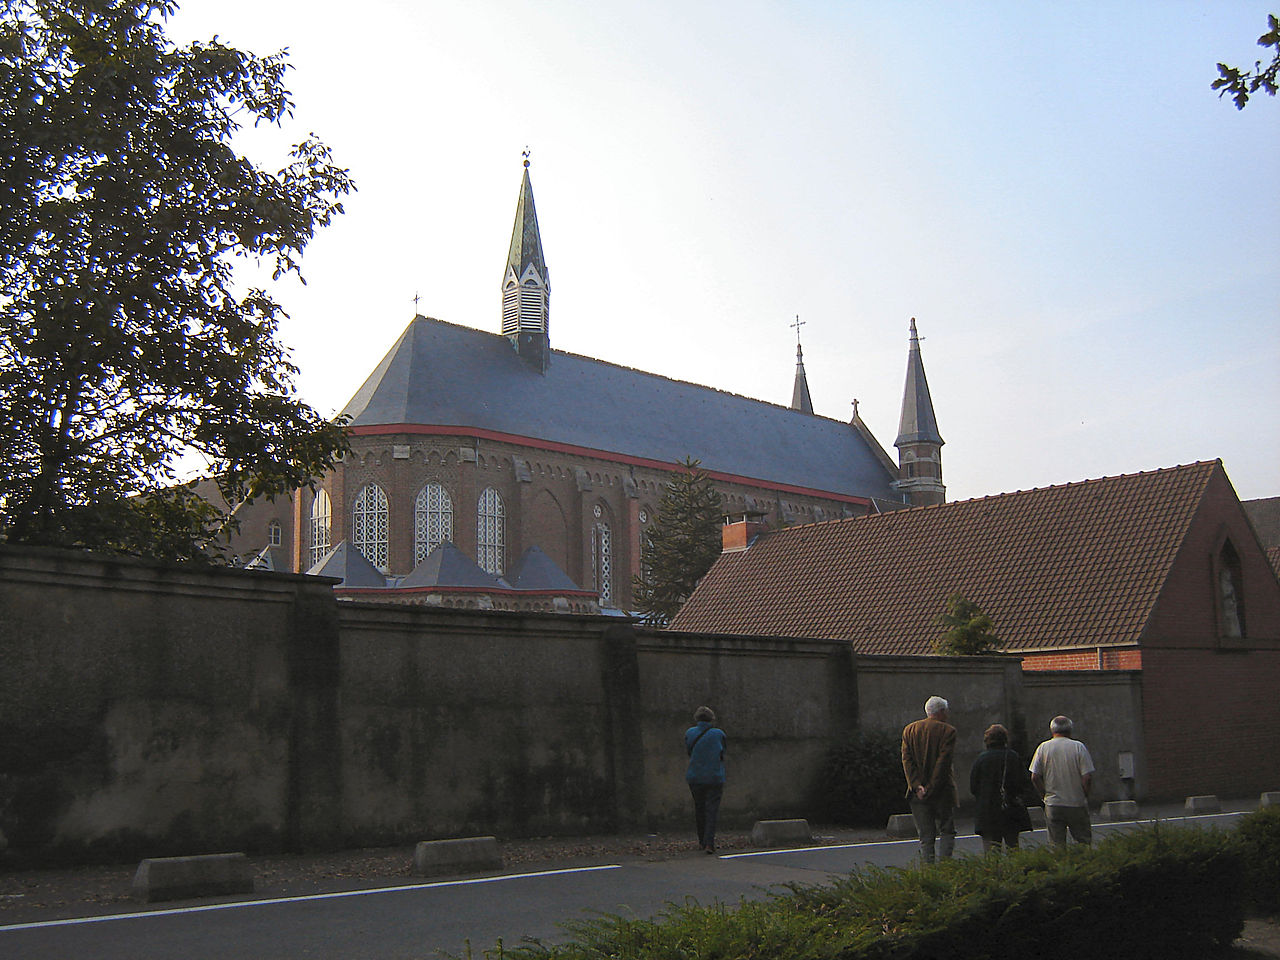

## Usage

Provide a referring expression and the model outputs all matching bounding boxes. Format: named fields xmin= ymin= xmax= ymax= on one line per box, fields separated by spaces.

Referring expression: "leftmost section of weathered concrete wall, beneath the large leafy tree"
xmin=0 ymin=548 xmax=333 ymax=858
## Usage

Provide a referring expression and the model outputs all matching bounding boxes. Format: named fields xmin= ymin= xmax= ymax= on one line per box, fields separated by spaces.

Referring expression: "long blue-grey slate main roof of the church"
xmin=343 ymin=316 xmax=902 ymax=503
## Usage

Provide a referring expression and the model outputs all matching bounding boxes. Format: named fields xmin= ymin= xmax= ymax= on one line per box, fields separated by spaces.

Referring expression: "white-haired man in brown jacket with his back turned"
xmin=902 ymin=696 xmax=960 ymax=863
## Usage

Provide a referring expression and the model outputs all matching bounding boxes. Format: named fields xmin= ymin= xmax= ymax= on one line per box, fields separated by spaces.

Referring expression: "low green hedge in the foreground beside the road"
xmin=486 ymin=826 xmax=1243 ymax=960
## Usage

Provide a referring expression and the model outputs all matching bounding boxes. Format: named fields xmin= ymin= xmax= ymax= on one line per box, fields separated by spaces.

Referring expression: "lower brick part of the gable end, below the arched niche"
xmin=1142 ymin=649 xmax=1280 ymax=799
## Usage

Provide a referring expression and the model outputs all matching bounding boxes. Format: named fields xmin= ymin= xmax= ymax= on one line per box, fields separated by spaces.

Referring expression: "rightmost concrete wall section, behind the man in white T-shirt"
xmin=1023 ymin=669 xmax=1146 ymax=803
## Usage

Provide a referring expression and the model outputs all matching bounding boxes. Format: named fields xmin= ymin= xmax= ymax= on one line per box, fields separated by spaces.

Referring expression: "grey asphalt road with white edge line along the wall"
xmin=0 ymin=813 xmax=1242 ymax=960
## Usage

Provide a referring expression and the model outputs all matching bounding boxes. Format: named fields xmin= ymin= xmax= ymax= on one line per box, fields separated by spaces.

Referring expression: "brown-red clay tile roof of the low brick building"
xmin=671 ymin=461 xmax=1225 ymax=654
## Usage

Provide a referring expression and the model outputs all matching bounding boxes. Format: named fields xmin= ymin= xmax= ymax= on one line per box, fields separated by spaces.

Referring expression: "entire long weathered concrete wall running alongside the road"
xmin=0 ymin=545 xmax=1167 ymax=861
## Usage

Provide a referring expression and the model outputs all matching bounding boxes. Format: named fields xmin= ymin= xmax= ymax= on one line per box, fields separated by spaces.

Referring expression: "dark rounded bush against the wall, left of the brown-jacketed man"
xmin=817 ymin=731 xmax=908 ymax=827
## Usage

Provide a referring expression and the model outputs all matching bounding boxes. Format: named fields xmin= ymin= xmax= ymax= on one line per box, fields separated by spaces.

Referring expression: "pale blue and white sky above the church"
xmin=169 ymin=0 xmax=1280 ymax=499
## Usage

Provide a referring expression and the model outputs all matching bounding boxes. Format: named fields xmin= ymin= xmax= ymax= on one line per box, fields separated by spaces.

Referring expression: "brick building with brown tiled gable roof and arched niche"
xmin=671 ymin=461 xmax=1280 ymax=796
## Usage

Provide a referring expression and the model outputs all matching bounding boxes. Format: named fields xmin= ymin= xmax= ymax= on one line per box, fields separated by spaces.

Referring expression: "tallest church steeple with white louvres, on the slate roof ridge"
xmin=502 ymin=148 xmax=552 ymax=372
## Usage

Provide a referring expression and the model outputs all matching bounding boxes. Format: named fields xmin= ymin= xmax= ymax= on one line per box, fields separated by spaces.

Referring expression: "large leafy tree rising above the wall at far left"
xmin=0 ymin=0 xmax=353 ymax=558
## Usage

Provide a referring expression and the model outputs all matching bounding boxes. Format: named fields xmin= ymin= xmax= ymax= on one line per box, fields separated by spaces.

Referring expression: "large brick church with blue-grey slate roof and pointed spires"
xmin=257 ymin=160 xmax=945 ymax=611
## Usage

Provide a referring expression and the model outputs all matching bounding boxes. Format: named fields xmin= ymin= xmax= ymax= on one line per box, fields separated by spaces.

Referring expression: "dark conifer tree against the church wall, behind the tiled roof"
xmin=632 ymin=457 xmax=723 ymax=623
